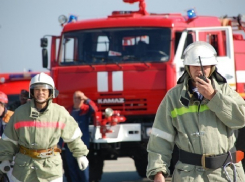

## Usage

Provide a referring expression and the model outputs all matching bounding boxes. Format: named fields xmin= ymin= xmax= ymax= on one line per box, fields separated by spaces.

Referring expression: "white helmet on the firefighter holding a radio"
xmin=184 ymin=41 xmax=218 ymax=66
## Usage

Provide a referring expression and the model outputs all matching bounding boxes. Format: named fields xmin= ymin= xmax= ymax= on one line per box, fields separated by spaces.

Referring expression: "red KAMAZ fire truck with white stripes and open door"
xmin=41 ymin=0 xmax=245 ymax=179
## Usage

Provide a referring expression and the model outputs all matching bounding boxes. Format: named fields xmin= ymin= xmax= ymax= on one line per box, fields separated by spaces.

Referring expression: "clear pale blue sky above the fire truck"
xmin=0 ymin=0 xmax=245 ymax=73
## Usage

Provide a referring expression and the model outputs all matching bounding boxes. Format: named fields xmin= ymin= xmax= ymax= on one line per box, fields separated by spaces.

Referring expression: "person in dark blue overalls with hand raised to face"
xmin=64 ymin=91 xmax=98 ymax=182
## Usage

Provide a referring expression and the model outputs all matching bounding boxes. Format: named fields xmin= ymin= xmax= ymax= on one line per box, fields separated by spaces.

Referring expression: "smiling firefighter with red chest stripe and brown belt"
xmin=0 ymin=73 xmax=88 ymax=182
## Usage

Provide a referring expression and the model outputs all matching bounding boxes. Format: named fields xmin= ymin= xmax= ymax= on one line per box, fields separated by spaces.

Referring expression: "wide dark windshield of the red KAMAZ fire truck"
xmin=59 ymin=27 xmax=171 ymax=65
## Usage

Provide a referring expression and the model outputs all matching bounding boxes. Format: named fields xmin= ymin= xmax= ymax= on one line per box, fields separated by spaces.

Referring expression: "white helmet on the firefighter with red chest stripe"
xmin=29 ymin=72 xmax=58 ymax=100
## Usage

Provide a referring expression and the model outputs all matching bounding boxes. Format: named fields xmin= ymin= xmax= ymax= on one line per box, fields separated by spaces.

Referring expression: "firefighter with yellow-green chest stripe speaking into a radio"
xmin=147 ymin=41 xmax=245 ymax=182
